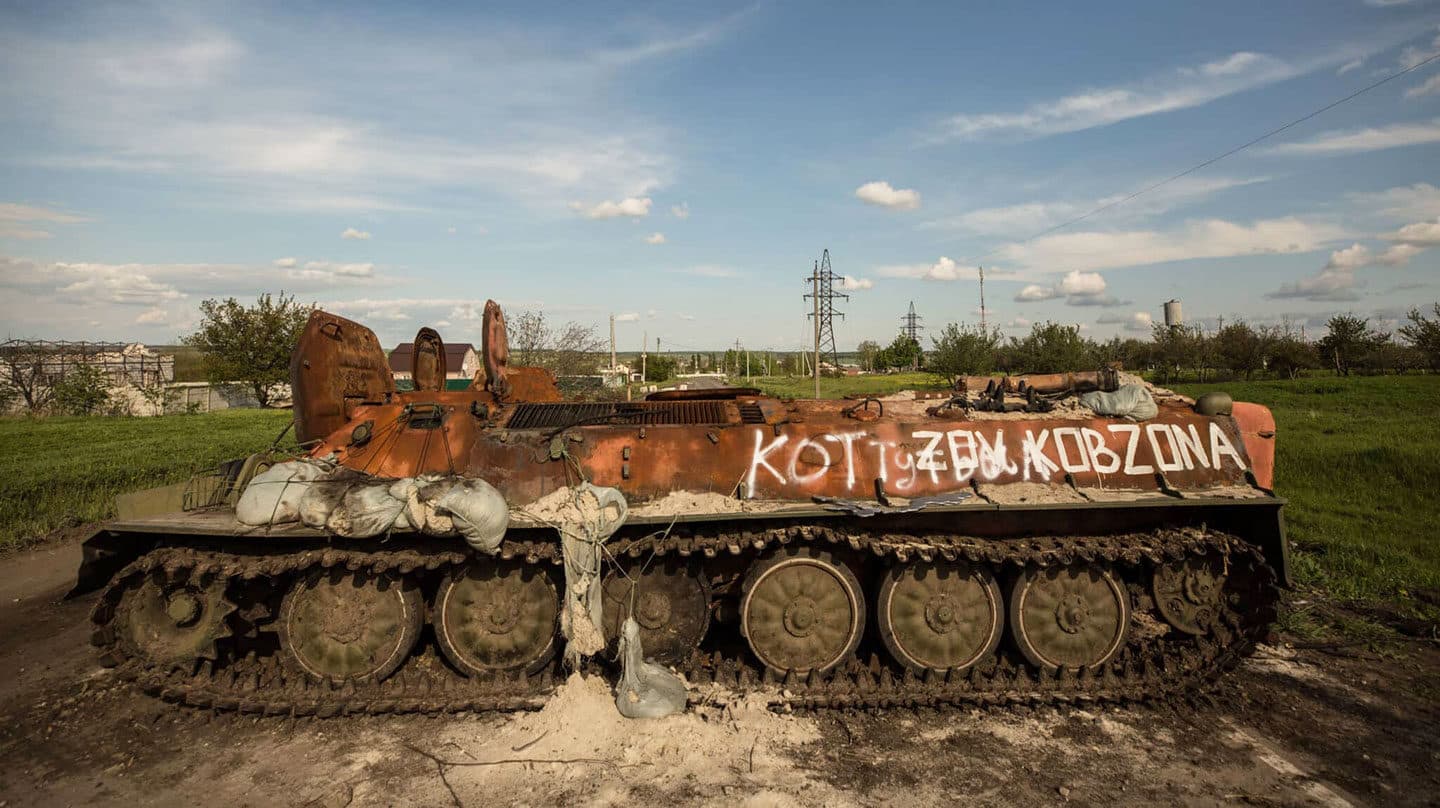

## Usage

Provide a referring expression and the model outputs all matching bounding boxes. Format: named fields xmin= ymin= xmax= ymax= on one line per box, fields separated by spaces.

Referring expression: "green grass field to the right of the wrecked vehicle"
xmin=1179 ymin=376 xmax=1440 ymax=633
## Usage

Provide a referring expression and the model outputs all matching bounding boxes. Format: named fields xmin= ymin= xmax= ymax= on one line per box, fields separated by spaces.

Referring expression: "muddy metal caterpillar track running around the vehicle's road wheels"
xmin=91 ymin=524 xmax=1279 ymax=716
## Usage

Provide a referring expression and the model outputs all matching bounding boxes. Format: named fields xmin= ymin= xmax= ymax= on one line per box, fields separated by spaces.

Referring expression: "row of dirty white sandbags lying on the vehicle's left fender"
xmin=235 ymin=459 xmax=510 ymax=553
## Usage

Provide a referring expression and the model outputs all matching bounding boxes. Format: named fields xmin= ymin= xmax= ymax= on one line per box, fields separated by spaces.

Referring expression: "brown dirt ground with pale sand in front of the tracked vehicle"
xmin=0 ymin=544 xmax=1440 ymax=808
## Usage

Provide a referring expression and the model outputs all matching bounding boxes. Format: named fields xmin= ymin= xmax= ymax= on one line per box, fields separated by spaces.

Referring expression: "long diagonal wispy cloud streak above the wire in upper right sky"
xmin=936 ymin=50 xmax=1305 ymax=140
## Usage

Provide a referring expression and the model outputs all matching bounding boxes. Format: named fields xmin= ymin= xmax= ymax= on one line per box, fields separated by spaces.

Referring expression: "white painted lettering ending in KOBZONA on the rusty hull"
xmin=746 ymin=419 xmax=1247 ymax=497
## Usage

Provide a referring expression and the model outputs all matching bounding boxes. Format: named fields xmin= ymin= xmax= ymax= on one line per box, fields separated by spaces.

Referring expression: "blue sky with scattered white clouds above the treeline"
xmin=0 ymin=0 xmax=1440 ymax=350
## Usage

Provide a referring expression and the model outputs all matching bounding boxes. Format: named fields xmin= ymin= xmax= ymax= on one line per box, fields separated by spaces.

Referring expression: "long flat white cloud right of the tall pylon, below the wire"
xmin=996 ymin=216 xmax=1345 ymax=271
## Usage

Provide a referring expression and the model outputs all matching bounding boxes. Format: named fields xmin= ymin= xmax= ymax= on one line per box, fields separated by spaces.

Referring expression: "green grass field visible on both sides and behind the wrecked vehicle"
xmin=0 ymin=373 xmax=1440 ymax=636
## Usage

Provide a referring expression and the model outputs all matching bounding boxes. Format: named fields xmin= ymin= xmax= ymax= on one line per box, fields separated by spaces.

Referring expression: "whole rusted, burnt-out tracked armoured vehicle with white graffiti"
xmin=78 ymin=302 xmax=1287 ymax=714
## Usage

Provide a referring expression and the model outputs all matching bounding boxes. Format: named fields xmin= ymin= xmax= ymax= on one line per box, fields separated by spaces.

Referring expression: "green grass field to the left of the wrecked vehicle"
xmin=0 ymin=409 xmax=289 ymax=550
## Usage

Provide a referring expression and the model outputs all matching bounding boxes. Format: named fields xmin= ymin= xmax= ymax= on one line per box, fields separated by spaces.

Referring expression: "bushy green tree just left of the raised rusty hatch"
xmin=184 ymin=292 xmax=315 ymax=408
